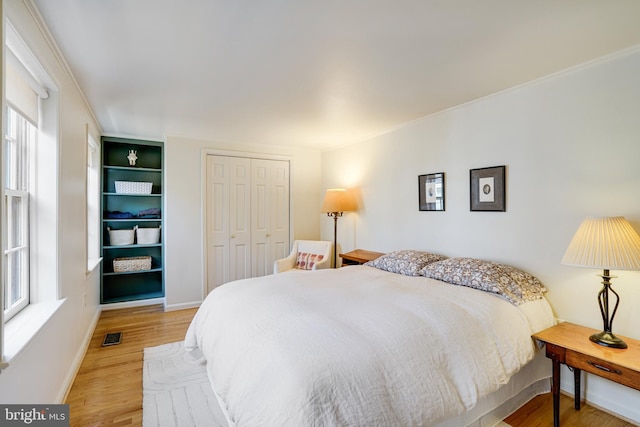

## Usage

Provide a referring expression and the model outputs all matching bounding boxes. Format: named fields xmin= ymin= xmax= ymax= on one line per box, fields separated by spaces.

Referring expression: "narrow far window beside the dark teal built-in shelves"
xmin=87 ymin=134 xmax=100 ymax=272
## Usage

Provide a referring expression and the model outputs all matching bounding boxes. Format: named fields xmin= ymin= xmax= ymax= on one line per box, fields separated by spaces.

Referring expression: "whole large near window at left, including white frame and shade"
xmin=0 ymin=21 xmax=59 ymax=328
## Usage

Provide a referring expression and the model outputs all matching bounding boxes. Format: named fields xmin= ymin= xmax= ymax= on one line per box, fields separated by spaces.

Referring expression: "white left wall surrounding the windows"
xmin=0 ymin=0 xmax=100 ymax=403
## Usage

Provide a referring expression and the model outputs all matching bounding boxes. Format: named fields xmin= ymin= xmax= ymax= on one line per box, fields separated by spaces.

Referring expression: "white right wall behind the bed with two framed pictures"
xmin=322 ymin=48 xmax=640 ymax=422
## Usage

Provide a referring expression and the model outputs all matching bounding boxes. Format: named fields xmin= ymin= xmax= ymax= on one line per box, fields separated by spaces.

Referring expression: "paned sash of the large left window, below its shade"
xmin=4 ymin=107 xmax=37 ymax=320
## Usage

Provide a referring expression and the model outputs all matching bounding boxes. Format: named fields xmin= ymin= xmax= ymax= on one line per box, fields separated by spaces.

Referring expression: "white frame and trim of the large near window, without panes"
xmin=0 ymin=17 xmax=63 ymax=330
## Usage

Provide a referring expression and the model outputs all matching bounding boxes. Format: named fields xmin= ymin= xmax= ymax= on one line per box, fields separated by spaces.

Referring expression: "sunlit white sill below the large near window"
xmin=3 ymin=299 xmax=66 ymax=362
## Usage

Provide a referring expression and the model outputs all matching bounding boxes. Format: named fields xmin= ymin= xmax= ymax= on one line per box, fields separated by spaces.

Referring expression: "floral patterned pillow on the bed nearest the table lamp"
xmin=420 ymin=258 xmax=547 ymax=305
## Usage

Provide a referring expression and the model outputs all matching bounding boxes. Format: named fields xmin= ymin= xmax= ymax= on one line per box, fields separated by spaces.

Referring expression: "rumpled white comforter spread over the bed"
xmin=185 ymin=266 xmax=553 ymax=427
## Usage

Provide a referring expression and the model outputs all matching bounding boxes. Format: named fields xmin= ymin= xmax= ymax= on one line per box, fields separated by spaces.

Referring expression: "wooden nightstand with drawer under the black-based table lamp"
xmin=533 ymin=322 xmax=640 ymax=427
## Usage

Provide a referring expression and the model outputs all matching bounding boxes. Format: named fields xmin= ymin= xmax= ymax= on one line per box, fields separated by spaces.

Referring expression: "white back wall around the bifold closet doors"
xmin=164 ymin=137 xmax=321 ymax=310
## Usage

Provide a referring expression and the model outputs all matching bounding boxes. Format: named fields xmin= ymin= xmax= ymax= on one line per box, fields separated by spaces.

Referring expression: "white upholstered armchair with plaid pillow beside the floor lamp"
xmin=273 ymin=240 xmax=333 ymax=274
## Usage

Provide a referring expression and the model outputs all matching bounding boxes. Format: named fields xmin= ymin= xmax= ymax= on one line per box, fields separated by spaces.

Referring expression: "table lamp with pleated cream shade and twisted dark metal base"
xmin=562 ymin=217 xmax=640 ymax=348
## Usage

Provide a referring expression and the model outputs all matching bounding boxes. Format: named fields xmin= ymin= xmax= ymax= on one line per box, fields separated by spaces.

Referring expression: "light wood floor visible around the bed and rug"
xmin=66 ymin=306 xmax=633 ymax=427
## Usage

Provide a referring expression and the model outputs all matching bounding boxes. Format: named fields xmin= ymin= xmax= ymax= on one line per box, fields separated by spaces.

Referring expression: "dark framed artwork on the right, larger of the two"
xmin=469 ymin=166 xmax=506 ymax=212
